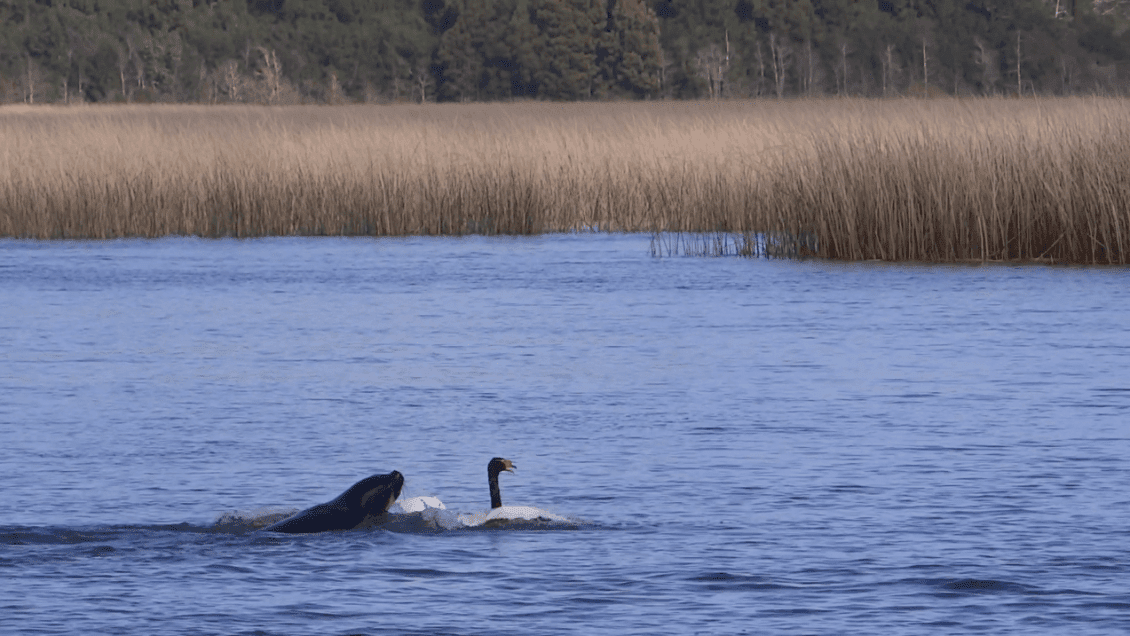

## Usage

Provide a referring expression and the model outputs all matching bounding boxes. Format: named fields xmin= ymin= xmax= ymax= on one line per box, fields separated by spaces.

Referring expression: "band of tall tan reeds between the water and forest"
xmin=0 ymin=97 xmax=1130 ymax=264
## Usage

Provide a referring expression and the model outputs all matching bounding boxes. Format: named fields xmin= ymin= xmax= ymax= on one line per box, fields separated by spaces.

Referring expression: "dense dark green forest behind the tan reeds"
xmin=0 ymin=0 xmax=1130 ymax=104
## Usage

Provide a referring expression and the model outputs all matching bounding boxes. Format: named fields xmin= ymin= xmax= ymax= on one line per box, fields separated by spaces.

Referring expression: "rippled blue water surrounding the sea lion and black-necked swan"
xmin=0 ymin=235 xmax=1130 ymax=636
